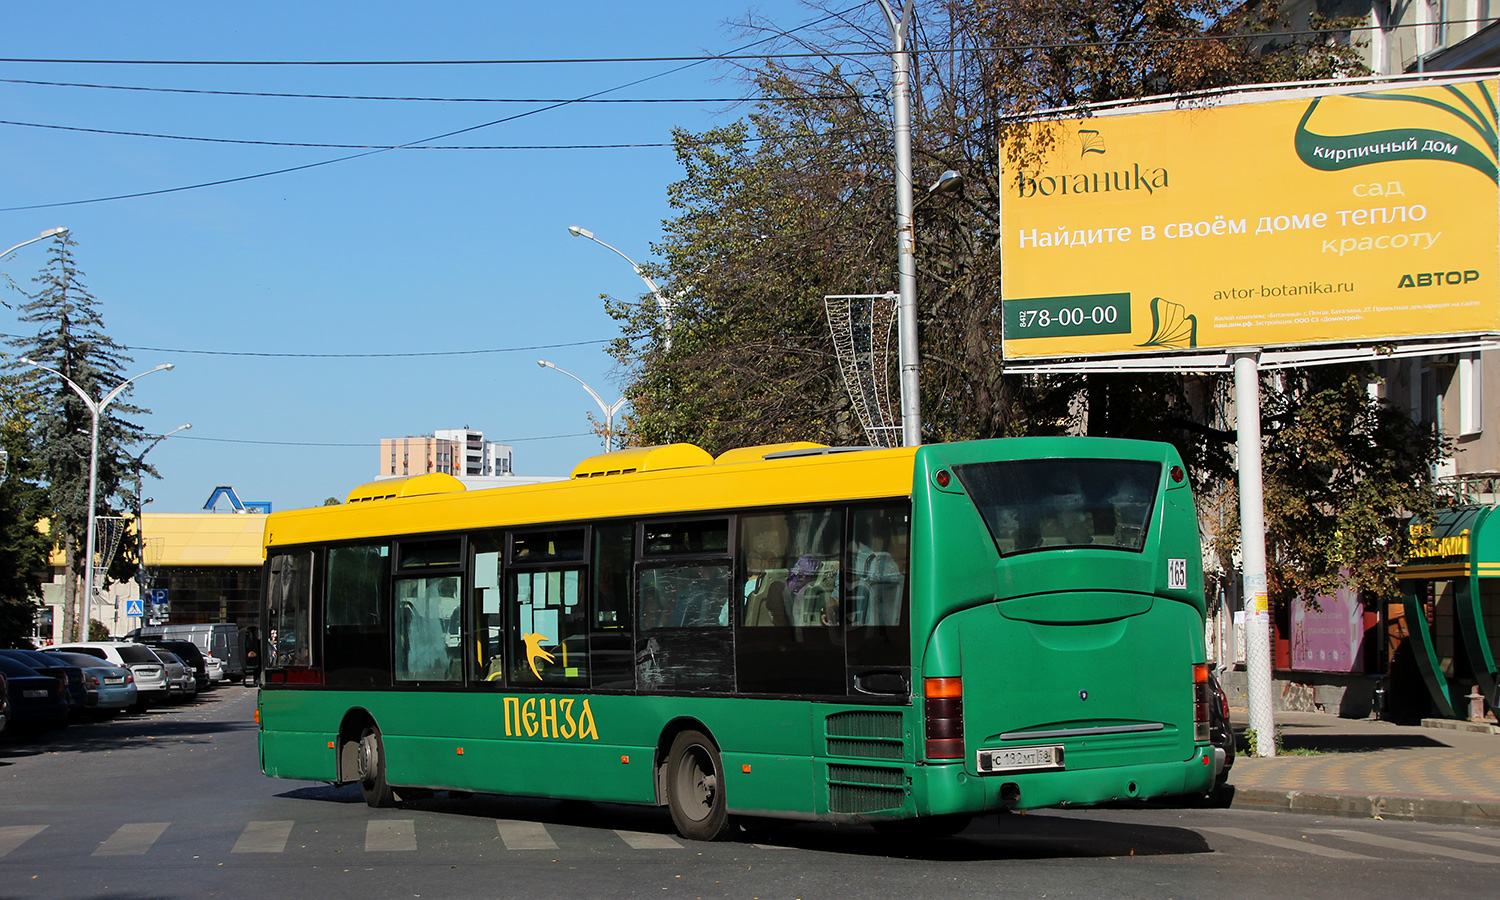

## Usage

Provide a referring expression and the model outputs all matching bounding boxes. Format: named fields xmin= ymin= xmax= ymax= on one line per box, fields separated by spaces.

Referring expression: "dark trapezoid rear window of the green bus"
xmin=953 ymin=459 xmax=1161 ymax=557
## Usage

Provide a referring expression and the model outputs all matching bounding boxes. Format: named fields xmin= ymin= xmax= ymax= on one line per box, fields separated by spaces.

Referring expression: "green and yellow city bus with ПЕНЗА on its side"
xmin=257 ymin=438 xmax=1214 ymax=840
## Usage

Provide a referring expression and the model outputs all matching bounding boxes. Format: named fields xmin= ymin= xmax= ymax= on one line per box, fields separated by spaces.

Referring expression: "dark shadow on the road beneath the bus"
xmin=278 ymin=785 xmax=1214 ymax=863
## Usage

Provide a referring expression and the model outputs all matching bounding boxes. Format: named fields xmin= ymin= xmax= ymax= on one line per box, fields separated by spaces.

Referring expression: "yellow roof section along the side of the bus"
xmin=266 ymin=444 xmax=917 ymax=546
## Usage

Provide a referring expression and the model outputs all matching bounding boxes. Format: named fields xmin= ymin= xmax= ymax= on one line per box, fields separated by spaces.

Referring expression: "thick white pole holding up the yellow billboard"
xmin=1235 ymin=350 xmax=1277 ymax=756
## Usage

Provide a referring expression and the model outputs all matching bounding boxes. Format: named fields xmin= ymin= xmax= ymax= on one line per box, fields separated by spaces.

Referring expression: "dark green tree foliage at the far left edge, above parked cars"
xmin=0 ymin=377 xmax=53 ymax=647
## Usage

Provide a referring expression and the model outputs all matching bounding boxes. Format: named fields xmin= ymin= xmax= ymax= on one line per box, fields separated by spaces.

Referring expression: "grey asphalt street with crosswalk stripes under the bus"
xmin=0 ymin=687 xmax=1500 ymax=900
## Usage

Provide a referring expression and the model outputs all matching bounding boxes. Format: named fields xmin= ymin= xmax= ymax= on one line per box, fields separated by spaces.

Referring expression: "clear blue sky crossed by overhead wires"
xmin=0 ymin=0 xmax=818 ymax=512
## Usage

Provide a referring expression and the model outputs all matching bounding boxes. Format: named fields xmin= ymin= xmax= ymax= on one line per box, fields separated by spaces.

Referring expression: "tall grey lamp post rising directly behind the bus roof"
xmin=878 ymin=0 xmax=923 ymax=447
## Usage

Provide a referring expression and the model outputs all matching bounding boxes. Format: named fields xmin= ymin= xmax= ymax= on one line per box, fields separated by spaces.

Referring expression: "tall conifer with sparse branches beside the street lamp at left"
xmin=9 ymin=233 xmax=155 ymax=635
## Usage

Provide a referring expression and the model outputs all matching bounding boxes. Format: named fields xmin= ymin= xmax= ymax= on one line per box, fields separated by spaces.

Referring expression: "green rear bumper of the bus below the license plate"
xmin=912 ymin=746 xmax=1214 ymax=816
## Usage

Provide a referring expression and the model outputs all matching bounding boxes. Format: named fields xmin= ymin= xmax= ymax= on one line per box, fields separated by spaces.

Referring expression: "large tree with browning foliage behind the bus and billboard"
xmin=612 ymin=0 xmax=1358 ymax=456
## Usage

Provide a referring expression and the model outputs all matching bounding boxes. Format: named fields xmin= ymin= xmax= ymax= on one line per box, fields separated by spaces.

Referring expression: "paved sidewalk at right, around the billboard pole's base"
xmin=1229 ymin=710 xmax=1500 ymax=827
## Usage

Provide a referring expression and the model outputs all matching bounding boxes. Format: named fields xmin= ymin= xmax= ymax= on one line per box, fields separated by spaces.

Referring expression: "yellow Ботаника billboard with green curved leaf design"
xmin=1001 ymin=80 xmax=1500 ymax=359
